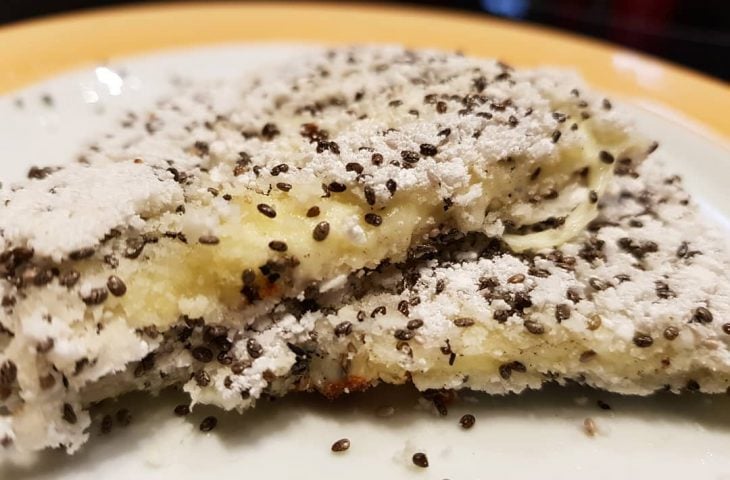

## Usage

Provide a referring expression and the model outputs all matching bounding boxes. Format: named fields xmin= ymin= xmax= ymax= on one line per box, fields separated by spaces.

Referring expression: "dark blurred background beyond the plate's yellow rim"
xmin=0 ymin=0 xmax=730 ymax=81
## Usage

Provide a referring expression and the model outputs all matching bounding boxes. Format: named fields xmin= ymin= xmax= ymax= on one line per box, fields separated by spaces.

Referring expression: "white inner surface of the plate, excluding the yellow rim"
xmin=0 ymin=44 xmax=730 ymax=480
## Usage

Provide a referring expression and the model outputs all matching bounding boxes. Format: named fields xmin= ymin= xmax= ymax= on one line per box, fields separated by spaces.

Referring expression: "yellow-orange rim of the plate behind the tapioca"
xmin=0 ymin=2 xmax=730 ymax=139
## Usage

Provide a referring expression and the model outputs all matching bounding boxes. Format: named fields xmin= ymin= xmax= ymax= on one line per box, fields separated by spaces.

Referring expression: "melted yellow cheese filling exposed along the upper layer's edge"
xmin=95 ymin=126 xmax=632 ymax=327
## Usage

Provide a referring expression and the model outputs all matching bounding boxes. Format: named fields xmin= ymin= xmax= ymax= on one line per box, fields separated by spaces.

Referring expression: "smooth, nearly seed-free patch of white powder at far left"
xmin=0 ymin=162 xmax=182 ymax=261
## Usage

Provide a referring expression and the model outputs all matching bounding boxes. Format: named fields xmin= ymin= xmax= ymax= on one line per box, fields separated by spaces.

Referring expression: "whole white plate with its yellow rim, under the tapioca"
xmin=0 ymin=5 xmax=730 ymax=480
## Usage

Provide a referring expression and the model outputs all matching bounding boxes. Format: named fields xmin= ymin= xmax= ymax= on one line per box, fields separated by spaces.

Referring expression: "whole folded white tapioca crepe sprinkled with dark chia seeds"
xmin=0 ymin=47 xmax=730 ymax=452
